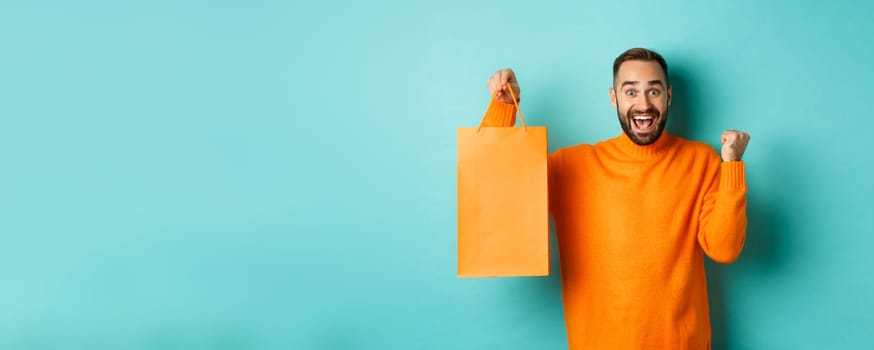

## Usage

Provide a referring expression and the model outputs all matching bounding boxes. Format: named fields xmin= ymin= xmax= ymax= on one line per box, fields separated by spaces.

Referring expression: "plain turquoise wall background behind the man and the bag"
xmin=0 ymin=0 xmax=874 ymax=349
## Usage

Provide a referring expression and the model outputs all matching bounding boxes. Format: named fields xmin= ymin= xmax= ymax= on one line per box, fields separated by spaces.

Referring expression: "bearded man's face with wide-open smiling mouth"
xmin=610 ymin=60 xmax=671 ymax=146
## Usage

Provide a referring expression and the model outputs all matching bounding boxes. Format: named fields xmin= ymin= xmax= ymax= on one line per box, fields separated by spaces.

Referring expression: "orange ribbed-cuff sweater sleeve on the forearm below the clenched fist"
xmin=698 ymin=161 xmax=747 ymax=264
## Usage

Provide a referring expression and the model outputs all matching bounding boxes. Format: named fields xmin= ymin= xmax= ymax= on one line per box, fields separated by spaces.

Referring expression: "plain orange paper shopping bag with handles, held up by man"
xmin=458 ymin=89 xmax=549 ymax=277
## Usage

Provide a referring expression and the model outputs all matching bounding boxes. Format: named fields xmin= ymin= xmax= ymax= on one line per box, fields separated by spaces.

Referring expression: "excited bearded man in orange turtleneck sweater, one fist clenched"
xmin=486 ymin=48 xmax=749 ymax=350
